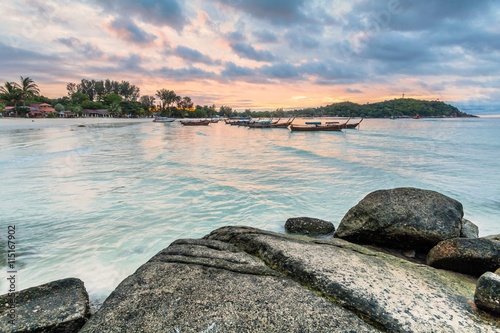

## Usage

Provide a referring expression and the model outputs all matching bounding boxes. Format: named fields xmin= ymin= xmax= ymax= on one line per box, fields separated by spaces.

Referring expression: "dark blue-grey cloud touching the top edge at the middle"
xmin=217 ymin=0 xmax=306 ymax=25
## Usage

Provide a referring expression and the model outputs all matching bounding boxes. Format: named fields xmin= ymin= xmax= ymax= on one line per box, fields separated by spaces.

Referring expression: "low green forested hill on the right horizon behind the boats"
xmin=301 ymin=98 xmax=473 ymax=118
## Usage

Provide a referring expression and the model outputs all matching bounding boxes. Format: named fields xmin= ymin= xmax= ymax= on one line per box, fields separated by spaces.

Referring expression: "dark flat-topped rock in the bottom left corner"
xmin=0 ymin=278 xmax=89 ymax=333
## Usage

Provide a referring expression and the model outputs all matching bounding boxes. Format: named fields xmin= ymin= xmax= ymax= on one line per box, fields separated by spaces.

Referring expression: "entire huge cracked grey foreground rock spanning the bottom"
xmin=82 ymin=227 xmax=500 ymax=332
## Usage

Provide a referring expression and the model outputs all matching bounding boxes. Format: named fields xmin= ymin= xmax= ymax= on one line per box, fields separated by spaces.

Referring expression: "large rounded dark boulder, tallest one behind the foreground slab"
xmin=334 ymin=188 xmax=463 ymax=252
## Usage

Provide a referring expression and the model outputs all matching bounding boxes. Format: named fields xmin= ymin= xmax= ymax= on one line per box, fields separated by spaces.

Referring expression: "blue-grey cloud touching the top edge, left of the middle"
xmin=93 ymin=0 xmax=188 ymax=31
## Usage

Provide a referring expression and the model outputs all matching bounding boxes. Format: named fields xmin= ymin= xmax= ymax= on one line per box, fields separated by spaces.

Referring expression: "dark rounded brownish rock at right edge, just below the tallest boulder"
xmin=427 ymin=238 xmax=500 ymax=276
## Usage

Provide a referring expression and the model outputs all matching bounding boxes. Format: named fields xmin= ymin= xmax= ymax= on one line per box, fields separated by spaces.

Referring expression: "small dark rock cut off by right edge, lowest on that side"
xmin=474 ymin=272 xmax=500 ymax=314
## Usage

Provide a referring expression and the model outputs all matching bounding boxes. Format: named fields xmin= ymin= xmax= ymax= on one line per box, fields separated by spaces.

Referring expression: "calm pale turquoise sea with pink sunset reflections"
xmin=0 ymin=116 xmax=500 ymax=304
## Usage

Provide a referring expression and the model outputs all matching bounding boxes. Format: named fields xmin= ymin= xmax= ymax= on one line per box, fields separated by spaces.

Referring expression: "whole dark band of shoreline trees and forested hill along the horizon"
xmin=0 ymin=76 xmax=470 ymax=118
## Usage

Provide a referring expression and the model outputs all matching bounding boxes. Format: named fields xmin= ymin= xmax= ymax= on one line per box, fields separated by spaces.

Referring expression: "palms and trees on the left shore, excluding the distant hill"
xmin=0 ymin=77 xmax=236 ymax=118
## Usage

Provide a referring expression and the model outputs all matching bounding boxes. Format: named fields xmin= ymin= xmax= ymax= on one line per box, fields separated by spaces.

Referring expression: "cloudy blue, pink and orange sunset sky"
xmin=0 ymin=0 xmax=500 ymax=113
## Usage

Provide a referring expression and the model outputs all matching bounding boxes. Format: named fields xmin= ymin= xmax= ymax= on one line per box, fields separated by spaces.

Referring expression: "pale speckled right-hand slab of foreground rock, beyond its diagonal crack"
xmin=206 ymin=227 xmax=500 ymax=332
